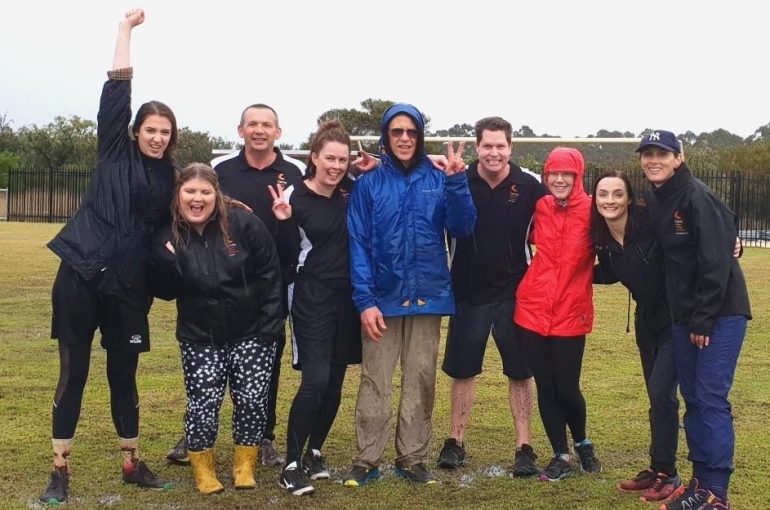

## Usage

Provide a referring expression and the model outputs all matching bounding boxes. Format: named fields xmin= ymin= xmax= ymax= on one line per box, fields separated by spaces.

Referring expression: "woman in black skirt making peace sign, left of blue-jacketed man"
xmin=270 ymin=120 xmax=361 ymax=496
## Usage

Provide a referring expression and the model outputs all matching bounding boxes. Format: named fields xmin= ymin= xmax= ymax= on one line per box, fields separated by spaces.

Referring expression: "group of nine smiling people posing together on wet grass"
xmin=41 ymin=10 xmax=750 ymax=510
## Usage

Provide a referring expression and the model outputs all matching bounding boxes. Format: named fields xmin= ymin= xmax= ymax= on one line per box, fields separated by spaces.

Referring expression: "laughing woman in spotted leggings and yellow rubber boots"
xmin=153 ymin=163 xmax=283 ymax=494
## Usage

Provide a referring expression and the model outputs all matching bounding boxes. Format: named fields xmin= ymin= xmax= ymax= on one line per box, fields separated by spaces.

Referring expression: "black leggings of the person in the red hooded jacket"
xmin=519 ymin=328 xmax=586 ymax=454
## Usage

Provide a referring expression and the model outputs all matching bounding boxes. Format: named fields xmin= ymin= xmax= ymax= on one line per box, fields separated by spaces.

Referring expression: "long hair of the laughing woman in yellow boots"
xmin=171 ymin=163 xmax=231 ymax=247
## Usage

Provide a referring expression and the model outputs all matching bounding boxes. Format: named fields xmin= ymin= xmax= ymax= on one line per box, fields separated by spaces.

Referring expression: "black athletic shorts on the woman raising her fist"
xmin=51 ymin=263 xmax=152 ymax=352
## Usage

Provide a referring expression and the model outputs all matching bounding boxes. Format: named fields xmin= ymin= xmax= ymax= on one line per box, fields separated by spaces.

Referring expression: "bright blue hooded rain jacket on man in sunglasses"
xmin=348 ymin=103 xmax=476 ymax=317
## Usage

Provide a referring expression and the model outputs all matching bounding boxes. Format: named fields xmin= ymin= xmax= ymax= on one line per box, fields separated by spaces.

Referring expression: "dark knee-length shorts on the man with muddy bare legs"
xmin=441 ymin=299 xmax=532 ymax=381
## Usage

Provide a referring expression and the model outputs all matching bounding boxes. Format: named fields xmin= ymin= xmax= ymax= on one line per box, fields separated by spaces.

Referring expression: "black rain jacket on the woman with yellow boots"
xmin=151 ymin=207 xmax=284 ymax=345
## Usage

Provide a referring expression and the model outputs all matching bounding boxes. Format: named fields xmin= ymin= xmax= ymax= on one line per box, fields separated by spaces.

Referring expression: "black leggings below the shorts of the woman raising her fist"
xmin=53 ymin=341 xmax=139 ymax=439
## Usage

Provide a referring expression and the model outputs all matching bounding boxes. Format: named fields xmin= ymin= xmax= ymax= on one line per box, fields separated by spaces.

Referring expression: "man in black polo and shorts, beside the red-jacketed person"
xmin=438 ymin=117 xmax=545 ymax=476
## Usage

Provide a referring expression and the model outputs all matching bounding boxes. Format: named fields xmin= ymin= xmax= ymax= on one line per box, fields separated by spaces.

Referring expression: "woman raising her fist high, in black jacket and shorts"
xmin=40 ymin=10 xmax=177 ymax=503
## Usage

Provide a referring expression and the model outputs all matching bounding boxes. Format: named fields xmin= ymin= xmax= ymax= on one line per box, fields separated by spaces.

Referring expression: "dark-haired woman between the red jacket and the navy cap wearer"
xmin=591 ymin=170 xmax=682 ymax=501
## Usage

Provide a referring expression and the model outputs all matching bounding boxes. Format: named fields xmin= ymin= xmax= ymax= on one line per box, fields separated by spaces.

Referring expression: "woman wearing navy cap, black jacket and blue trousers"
xmin=636 ymin=131 xmax=751 ymax=510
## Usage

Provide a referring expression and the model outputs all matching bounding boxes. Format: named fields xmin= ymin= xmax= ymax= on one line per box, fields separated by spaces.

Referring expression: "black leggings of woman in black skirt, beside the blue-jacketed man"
xmin=286 ymin=360 xmax=347 ymax=464
